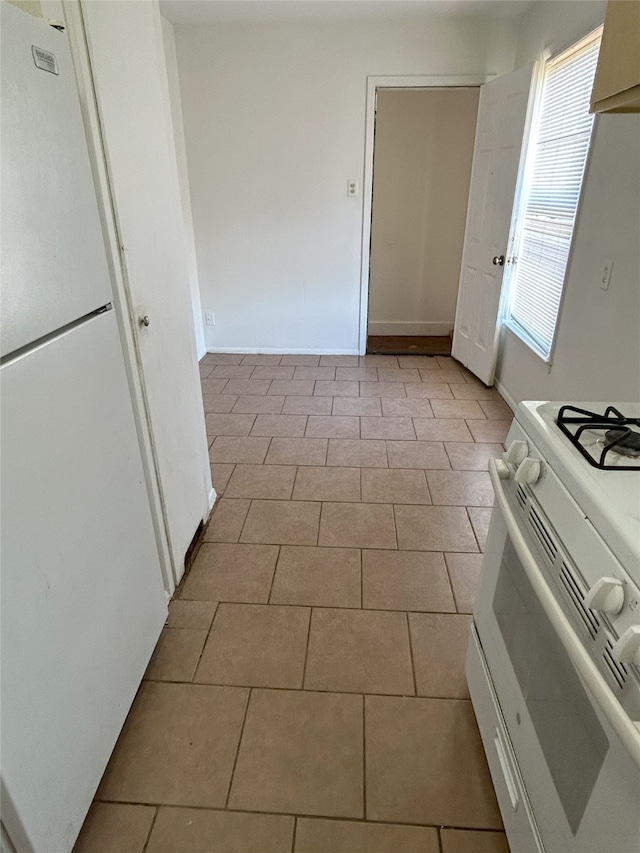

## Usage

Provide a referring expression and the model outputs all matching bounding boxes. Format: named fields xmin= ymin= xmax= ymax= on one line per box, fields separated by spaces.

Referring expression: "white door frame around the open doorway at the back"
xmin=358 ymin=74 xmax=497 ymax=355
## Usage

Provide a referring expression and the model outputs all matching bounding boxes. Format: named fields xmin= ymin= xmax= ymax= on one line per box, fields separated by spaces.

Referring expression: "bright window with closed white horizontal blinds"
xmin=506 ymin=28 xmax=601 ymax=360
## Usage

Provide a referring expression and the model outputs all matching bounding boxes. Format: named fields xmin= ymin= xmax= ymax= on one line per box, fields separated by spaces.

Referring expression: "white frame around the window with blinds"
xmin=500 ymin=25 xmax=603 ymax=370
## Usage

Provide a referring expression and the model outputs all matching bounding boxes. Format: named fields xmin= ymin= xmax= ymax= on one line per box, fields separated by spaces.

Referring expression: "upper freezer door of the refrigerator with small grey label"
xmin=0 ymin=3 xmax=112 ymax=355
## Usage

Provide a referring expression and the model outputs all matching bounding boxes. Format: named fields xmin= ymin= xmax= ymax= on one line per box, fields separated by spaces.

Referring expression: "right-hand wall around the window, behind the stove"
xmin=497 ymin=2 xmax=640 ymax=402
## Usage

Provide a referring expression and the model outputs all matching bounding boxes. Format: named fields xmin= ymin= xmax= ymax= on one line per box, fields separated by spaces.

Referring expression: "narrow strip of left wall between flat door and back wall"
xmin=162 ymin=18 xmax=207 ymax=359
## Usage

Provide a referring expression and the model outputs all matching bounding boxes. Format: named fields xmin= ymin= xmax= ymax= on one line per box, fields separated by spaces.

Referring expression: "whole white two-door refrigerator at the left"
xmin=0 ymin=8 xmax=167 ymax=853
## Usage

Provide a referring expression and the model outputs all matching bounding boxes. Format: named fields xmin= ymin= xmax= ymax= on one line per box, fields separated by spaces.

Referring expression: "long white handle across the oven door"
xmin=489 ymin=459 xmax=640 ymax=767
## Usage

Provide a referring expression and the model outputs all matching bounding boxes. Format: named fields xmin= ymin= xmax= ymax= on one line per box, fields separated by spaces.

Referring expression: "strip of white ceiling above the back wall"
xmin=160 ymin=0 xmax=534 ymax=24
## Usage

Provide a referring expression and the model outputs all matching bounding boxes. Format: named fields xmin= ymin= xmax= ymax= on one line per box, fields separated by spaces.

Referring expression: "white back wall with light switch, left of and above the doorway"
xmin=175 ymin=17 xmax=515 ymax=352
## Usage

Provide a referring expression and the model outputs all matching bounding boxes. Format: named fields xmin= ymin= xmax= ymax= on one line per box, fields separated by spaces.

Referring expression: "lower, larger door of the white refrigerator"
xmin=0 ymin=311 xmax=167 ymax=853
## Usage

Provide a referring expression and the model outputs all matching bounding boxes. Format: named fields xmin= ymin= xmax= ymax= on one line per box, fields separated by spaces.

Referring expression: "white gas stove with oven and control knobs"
xmin=466 ymin=402 xmax=640 ymax=853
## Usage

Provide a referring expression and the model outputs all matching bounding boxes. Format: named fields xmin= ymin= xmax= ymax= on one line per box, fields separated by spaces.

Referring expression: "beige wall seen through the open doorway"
xmin=369 ymin=87 xmax=480 ymax=335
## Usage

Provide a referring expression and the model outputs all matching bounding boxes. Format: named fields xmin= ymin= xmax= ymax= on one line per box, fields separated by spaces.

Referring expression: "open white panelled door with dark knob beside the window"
xmin=452 ymin=65 xmax=533 ymax=385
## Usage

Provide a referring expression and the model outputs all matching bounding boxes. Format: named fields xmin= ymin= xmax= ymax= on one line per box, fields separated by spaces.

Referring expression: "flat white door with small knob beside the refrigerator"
xmin=82 ymin=2 xmax=214 ymax=581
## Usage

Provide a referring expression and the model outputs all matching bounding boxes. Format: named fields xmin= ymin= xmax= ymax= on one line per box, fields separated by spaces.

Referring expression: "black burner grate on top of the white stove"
xmin=556 ymin=406 xmax=640 ymax=471
